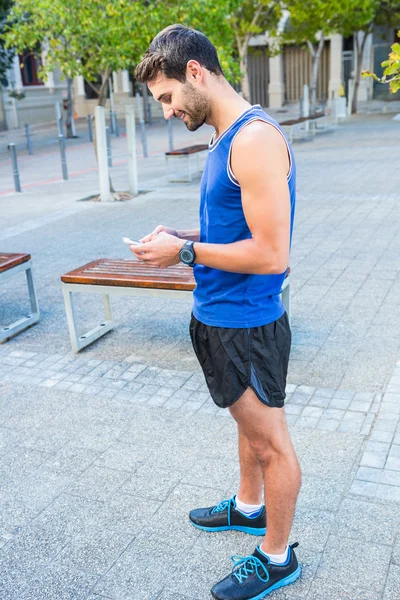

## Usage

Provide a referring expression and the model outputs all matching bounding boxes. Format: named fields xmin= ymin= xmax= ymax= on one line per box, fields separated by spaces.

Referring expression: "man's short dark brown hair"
xmin=135 ymin=25 xmax=223 ymax=83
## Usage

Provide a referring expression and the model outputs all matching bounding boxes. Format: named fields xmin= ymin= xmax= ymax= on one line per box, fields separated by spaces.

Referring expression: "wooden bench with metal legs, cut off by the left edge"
xmin=0 ymin=253 xmax=40 ymax=343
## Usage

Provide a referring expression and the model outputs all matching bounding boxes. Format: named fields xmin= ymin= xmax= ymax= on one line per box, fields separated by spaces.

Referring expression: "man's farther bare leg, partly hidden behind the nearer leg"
xmin=237 ymin=426 xmax=264 ymax=504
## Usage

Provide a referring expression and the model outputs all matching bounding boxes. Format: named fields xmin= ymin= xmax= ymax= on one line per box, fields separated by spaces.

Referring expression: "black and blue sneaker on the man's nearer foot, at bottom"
xmin=211 ymin=542 xmax=301 ymax=600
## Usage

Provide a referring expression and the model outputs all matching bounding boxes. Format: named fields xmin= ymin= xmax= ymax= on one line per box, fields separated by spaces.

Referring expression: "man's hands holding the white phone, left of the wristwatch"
xmin=129 ymin=227 xmax=185 ymax=269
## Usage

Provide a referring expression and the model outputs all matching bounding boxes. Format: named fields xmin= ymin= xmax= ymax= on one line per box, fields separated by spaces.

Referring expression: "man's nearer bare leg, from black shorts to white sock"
xmin=229 ymin=388 xmax=301 ymax=554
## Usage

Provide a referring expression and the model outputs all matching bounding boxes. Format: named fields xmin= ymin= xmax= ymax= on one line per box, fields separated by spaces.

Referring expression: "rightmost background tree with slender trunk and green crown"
xmin=337 ymin=0 xmax=400 ymax=114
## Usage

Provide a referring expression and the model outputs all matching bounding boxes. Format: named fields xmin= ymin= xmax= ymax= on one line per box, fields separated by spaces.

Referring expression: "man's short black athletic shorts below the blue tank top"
xmin=190 ymin=313 xmax=291 ymax=408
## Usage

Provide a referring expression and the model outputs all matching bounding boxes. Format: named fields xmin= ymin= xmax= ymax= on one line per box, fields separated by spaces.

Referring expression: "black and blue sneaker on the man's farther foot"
xmin=189 ymin=496 xmax=266 ymax=535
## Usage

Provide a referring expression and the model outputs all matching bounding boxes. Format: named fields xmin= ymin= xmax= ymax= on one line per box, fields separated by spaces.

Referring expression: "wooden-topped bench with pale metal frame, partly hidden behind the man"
xmin=61 ymin=258 xmax=290 ymax=352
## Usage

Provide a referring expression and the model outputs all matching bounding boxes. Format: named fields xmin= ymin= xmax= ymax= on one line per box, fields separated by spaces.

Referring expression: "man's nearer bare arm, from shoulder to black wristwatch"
xmin=194 ymin=121 xmax=290 ymax=274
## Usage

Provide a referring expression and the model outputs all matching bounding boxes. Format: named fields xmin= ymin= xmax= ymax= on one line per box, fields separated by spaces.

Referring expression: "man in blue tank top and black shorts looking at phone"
xmin=131 ymin=25 xmax=301 ymax=600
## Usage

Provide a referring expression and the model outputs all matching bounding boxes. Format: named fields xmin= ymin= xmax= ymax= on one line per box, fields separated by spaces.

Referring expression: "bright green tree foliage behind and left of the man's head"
xmin=0 ymin=0 xmax=247 ymax=92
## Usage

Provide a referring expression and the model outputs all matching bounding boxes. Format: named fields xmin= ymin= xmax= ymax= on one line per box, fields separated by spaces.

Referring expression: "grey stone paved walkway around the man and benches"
xmin=0 ymin=110 xmax=400 ymax=600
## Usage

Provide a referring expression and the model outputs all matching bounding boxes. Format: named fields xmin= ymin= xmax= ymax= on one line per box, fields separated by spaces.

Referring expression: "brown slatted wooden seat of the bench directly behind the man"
xmin=61 ymin=258 xmax=196 ymax=291
